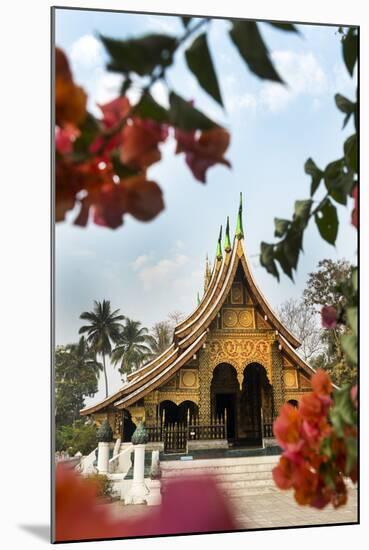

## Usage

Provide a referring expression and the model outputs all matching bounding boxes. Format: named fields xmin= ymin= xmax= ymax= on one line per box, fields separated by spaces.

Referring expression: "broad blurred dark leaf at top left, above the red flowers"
xmin=100 ymin=34 xmax=177 ymax=76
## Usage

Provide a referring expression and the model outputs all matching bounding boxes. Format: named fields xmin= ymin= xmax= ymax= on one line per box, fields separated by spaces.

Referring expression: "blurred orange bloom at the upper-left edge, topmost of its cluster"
xmin=55 ymin=48 xmax=87 ymax=126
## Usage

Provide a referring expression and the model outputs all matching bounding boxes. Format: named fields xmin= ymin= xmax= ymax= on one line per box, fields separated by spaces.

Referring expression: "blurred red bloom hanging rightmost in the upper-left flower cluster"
xmin=175 ymin=128 xmax=231 ymax=183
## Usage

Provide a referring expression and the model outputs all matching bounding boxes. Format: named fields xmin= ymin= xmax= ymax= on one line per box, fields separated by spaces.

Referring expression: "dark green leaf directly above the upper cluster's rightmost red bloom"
xmin=169 ymin=92 xmax=218 ymax=132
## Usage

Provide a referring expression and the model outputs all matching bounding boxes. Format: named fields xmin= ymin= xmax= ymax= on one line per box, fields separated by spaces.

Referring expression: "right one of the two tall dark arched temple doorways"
xmin=238 ymin=363 xmax=273 ymax=445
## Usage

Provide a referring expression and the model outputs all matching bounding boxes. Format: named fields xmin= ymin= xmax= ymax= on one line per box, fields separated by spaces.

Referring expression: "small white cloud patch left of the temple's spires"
xmin=138 ymin=254 xmax=189 ymax=291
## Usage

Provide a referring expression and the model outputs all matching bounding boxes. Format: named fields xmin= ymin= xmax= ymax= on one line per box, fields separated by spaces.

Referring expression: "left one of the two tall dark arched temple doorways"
xmin=210 ymin=363 xmax=239 ymax=443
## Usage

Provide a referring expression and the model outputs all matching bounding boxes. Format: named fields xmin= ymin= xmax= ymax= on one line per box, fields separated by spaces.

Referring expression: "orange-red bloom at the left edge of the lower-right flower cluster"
xmin=273 ymin=403 xmax=302 ymax=452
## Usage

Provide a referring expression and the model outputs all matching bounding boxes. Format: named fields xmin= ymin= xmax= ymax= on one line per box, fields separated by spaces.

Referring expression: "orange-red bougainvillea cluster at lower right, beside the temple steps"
xmin=273 ymin=369 xmax=357 ymax=508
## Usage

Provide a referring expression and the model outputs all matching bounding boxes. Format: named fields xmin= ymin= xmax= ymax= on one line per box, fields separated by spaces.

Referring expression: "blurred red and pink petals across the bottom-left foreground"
xmin=55 ymin=464 xmax=237 ymax=542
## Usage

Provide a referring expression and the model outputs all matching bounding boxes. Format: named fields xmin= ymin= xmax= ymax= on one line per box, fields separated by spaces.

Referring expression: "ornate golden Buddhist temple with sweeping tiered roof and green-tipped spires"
xmin=81 ymin=195 xmax=314 ymax=452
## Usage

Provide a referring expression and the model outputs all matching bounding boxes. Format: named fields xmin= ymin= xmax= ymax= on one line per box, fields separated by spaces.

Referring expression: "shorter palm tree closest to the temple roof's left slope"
xmin=111 ymin=317 xmax=151 ymax=374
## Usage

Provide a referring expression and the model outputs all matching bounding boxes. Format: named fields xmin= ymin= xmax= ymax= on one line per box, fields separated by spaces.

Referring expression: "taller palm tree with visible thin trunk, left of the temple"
xmin=79 ymin=300 xmax=125 ymax=397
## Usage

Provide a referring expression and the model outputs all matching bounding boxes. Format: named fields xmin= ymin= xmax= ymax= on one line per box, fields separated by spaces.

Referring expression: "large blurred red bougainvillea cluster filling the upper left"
xmin=55 ymin=48 xmax=230 ymax=229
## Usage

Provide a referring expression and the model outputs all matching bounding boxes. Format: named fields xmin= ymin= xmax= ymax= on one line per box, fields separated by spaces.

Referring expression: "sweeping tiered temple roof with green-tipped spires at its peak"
xmin=81 ymin=195 xmax=314 ymax=415
